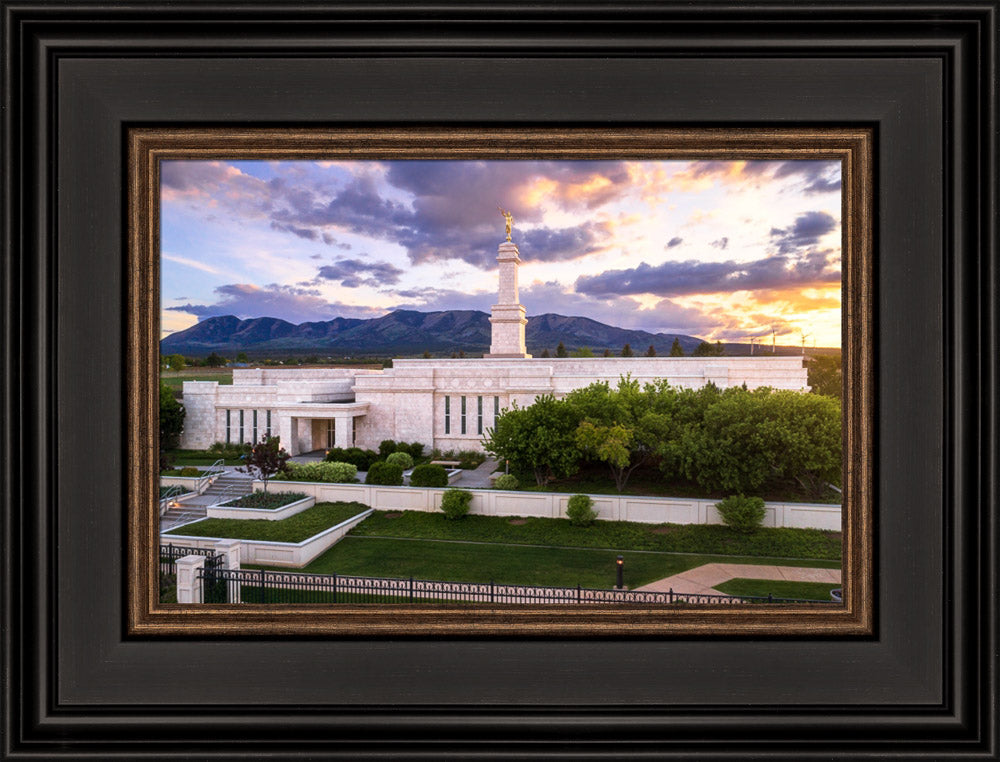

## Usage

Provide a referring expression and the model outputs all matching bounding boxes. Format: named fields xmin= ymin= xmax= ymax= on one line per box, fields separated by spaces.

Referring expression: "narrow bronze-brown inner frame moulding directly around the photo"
xmin=127 ymin=127 xmax=875 ymax=637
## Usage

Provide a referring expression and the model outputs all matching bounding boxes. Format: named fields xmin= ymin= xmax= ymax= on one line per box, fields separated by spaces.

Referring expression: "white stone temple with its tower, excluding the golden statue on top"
xmin=180 ymin=235 xmax=809 ymax=455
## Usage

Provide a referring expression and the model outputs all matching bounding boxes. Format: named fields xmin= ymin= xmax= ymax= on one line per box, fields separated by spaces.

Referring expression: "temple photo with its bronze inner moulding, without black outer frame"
xmin=128 ymin=128 xmax=872 ymax=636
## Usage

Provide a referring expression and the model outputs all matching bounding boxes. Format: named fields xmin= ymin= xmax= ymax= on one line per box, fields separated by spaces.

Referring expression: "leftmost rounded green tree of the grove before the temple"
xmin=483 ymin=395 xmax=581 ymax=486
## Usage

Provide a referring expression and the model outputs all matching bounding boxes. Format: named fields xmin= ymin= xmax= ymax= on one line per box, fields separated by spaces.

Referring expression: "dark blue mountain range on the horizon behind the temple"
xmin=160 ymin=310 xmax=731 ymax=357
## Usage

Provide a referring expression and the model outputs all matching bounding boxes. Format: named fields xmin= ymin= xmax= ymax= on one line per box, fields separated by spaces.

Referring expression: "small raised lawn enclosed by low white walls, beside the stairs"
xmin=166 ymin=503 xmax=368 ymax=542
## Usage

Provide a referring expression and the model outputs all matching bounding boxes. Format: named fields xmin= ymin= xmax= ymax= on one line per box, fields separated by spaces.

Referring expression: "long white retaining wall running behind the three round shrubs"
xmin=254 ymin=479 xmax=842 ymax=531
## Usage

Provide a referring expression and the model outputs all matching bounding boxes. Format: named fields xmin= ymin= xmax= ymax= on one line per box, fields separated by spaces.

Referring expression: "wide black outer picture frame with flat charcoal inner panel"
xmin=0 ymin=0 xmax=1000 ymax=760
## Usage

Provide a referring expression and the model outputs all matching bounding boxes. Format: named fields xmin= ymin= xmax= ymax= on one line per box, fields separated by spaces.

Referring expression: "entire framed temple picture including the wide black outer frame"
xmin=0 ymin=0 xmax=1000 ymax=759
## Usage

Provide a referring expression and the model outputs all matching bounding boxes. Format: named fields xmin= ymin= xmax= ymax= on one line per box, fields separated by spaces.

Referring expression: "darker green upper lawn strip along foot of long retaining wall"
xmin=351 ymin=511 xmax=841 ymax=568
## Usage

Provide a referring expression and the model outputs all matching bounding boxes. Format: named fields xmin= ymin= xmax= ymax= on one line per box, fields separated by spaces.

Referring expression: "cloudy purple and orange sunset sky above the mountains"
xmin=161 ymin=160 xmax=841 ymax=346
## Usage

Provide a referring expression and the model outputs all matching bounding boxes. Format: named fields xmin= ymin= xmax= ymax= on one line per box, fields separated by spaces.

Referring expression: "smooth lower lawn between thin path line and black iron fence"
xmin=246 ymin=536 xmax=836 ymax=595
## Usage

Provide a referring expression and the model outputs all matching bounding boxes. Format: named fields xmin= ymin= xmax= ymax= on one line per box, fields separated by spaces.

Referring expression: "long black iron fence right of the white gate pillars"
xmin=199 ymin=562 xmax=837 ymax=606
